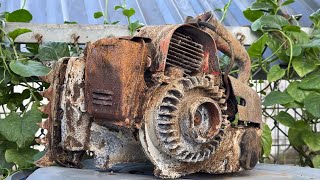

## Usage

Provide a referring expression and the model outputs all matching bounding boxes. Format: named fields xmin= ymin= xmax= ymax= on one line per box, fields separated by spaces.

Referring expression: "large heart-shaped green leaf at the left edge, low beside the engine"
xmin=0 ymin=104 xmax=42 ymax=147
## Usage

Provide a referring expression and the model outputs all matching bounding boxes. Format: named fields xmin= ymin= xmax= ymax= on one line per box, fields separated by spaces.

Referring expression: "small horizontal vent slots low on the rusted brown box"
xmin=92 ymin=90 xmax=113 ymax=106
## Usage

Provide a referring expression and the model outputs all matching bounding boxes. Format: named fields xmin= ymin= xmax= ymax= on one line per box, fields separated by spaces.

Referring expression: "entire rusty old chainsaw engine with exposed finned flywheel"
xmin=38 ymin=13 xmax=261 ymax=178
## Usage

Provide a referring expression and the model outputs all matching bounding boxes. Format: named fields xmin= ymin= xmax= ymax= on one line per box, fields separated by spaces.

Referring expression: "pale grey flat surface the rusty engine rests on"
xmin=21 ymin=164 xmax=320 ymax=180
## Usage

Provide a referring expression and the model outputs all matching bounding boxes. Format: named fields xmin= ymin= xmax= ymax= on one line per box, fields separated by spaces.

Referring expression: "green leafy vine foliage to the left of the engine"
xmin=0 ymin=9 xmax=82 ymax=176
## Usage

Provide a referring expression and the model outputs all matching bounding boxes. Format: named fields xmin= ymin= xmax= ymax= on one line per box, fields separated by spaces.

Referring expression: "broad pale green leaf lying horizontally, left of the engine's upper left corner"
xmin=9 ymin=59 xmax=51 ymax=77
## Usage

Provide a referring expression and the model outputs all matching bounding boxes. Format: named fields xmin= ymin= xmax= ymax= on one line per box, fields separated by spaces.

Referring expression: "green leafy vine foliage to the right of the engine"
xmin=243 ymin=0 xmax=320 ymax=167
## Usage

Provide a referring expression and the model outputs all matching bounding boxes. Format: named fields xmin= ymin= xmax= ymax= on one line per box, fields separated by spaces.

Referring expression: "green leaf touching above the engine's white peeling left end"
xmin=39 ymin=42 xmax=70 ymax=61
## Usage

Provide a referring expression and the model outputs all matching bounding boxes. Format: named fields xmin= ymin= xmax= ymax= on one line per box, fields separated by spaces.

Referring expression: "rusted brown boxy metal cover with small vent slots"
xmin=85 ymin=38 xmax=147 ymax=126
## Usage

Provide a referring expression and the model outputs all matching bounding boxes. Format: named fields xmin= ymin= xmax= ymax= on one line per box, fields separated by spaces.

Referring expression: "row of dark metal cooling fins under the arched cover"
xmin=166 ymin=32 xmax=204 ymax=74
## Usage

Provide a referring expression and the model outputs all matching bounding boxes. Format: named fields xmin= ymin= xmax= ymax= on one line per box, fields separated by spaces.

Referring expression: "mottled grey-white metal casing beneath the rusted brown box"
xmin=89 ymin=123 xmax=148 ymax=169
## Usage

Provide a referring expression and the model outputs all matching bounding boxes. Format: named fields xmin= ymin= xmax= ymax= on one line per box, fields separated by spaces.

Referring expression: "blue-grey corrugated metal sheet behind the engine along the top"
xmin=0 ymin=0 xmax=320 ymax=26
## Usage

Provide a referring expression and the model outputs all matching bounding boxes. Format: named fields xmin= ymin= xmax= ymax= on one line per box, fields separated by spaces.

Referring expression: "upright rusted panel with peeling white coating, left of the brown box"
xmin=60 ymin=58 xmax=91 ymax=151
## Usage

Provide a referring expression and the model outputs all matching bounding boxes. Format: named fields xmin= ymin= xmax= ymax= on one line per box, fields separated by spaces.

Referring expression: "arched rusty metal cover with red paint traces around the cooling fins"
xmin=136 ymin=25 xmax=220 ymax=75
